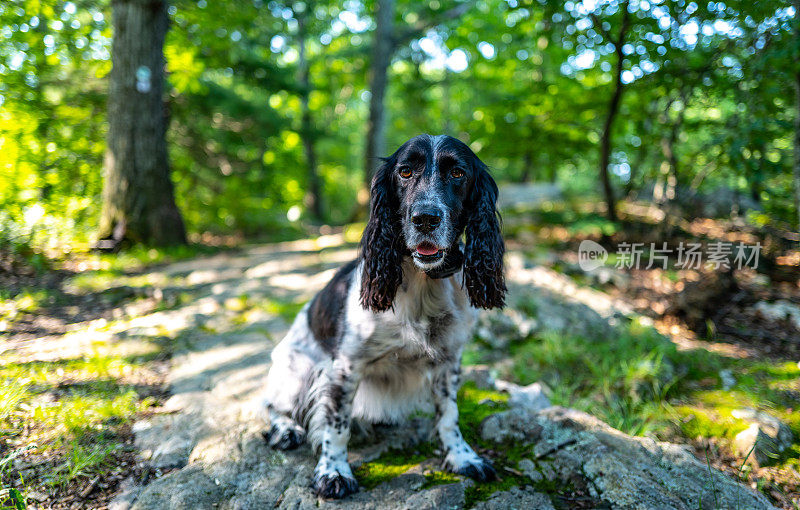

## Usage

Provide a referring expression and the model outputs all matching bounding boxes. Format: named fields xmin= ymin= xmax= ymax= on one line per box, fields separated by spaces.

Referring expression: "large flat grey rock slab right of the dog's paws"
xmin=482 ymin=407 xmax=773 ymax=509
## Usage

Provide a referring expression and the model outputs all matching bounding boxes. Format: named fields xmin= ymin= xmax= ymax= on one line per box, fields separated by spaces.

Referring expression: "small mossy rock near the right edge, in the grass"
xmin=731 ymin=408 xmax=792 ymax=466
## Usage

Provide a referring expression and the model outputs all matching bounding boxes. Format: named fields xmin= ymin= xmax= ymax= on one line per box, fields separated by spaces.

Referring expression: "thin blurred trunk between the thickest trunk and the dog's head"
xmin=297 ymin=11 xmax=323 ymax=222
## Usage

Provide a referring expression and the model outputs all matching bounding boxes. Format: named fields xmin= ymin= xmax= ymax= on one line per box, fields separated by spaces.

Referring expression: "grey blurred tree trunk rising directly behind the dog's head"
xmin=364 ymin=0 xmax=395 ymax=189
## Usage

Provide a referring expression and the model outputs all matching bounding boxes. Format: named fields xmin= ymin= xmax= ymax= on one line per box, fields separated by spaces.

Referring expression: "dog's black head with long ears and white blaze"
xmin=361 ymin=135 xmax=506 ymax=311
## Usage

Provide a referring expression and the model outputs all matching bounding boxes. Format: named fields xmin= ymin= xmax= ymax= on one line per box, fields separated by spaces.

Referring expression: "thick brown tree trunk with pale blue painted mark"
xmin=98 ymin=0 xmax=186 ymax=249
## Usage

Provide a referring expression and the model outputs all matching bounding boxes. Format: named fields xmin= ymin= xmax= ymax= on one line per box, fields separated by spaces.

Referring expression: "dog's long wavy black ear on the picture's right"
xmin=464 ymin=161 xmax=506 ymax=308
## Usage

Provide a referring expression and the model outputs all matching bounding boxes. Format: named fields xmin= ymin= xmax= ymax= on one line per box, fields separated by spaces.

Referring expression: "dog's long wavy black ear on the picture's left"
xmin=360 ymin=153 xmax=403 ymax=312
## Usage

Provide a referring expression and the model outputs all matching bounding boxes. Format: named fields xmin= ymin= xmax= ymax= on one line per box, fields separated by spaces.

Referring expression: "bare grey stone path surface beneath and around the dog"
xmin=108 ymin=241 xmax=768 ymax=510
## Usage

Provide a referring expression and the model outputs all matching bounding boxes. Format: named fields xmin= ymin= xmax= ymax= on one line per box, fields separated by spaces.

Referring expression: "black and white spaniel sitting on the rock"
xmin=265 ymin=135 xmax=506 ymax=498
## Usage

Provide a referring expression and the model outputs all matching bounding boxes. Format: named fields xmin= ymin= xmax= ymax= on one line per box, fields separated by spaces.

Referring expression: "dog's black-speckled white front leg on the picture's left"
xmin=312 ymin=356 xmax=360 ymax=499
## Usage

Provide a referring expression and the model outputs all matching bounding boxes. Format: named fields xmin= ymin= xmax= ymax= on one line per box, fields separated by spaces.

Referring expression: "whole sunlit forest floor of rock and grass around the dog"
xmin=0 ymin=190 xmax=800 ymax=510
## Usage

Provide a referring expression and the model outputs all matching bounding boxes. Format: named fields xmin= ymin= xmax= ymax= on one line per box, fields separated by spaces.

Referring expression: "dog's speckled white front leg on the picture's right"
xmin=433 ymin=356 xmax=497 ymax=482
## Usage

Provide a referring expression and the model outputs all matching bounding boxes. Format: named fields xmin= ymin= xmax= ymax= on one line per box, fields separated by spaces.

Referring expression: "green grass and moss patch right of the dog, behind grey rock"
xmin=500 ymin=321 xmax=800 ymax=465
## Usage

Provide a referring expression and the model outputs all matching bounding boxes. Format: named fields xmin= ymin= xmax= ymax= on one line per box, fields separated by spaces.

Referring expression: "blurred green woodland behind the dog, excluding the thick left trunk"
xmin=0 ymin=0 xmax=800 ymax=251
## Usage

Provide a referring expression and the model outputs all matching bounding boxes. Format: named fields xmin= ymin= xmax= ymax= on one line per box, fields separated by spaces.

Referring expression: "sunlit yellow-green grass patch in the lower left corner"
xmin=0 ymin=348 xmax=162 ymax=488
